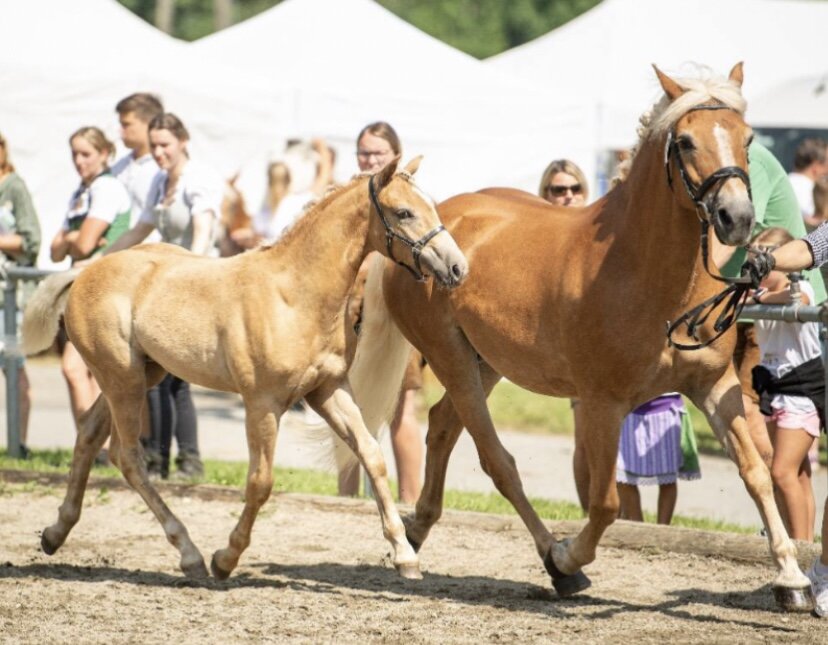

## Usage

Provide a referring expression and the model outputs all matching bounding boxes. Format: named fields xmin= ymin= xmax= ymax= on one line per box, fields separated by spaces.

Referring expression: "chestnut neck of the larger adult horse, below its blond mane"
xmin=618 ymin=136 xmax=714 ymax=306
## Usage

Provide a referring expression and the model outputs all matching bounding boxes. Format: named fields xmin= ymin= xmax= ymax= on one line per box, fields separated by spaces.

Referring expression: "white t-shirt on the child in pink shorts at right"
xmin=754 ymin=280 xmax=822 ymax=414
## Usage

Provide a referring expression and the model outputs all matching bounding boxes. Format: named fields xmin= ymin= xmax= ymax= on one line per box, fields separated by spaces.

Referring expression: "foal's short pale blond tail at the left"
xmin=21 ymin=269 xmax=81 ymax=356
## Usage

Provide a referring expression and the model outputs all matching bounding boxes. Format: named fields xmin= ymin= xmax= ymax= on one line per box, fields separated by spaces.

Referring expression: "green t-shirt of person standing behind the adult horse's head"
xmin=722 ymin=141 xmax=826 ymax=304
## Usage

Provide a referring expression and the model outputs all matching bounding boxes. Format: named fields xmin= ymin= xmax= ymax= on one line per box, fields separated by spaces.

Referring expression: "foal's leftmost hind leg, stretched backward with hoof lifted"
xmin=40 ymin=395 xmax=112 ymax=555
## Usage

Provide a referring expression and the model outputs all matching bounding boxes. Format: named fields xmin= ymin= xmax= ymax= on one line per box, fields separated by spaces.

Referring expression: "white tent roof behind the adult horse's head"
xmin=486 ymin=0 xmax=828 ymax=150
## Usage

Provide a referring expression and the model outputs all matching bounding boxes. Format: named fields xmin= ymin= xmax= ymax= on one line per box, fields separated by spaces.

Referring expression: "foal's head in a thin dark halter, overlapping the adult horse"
xmin=369 ymin=157 xmax=468 ymax=287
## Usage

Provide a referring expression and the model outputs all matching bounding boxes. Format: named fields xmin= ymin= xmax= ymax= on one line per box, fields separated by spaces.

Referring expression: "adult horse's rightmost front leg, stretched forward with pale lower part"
xmin=691 ymin=367 xmax=814 ymax=611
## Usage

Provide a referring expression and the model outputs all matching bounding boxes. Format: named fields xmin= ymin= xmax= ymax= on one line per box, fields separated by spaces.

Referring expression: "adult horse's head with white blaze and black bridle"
xmin=653 ymin=63 xmax=754 ymax=246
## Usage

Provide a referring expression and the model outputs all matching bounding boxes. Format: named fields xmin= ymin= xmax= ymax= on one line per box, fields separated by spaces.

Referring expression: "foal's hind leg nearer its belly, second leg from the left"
xmin=106 ymin=382 xmax=207 ymax=578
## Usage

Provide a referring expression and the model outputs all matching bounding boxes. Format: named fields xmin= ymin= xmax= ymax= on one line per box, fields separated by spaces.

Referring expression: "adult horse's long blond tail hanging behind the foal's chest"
xmin=336 ymin=254 xmax=411 ymax=470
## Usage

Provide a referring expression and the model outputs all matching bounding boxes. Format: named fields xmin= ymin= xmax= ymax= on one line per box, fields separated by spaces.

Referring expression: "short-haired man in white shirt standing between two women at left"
xmin=110 ymin=92 xmax=164 ymax=242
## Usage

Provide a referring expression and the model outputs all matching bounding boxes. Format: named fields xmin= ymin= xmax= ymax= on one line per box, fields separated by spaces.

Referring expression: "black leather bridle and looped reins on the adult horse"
xmin=664 ymin=103 xmax=753 ymax=350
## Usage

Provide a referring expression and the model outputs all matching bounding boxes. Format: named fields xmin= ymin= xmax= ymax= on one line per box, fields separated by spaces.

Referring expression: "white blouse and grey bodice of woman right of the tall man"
xmin=139 ymin=161 xmax=224 ymax=248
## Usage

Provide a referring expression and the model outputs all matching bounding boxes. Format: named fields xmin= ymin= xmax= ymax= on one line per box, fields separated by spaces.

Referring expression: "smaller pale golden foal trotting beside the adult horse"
xmin=23 ymin=158 xmax=467 ymax=578
